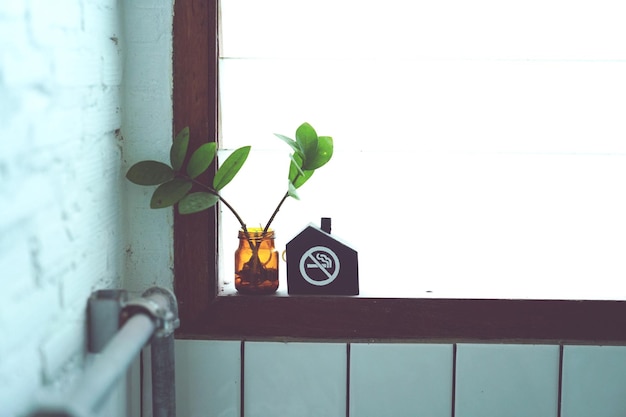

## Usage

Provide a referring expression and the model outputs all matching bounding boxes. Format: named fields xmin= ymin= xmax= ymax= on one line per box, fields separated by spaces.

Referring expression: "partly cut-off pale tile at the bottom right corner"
xmin=562 ymin=346 xmax=626 ymax=417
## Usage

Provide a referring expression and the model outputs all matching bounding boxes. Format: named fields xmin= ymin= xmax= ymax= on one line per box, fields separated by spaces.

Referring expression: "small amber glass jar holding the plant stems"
xmin=235 ymin=228 xmax=278 ymax=294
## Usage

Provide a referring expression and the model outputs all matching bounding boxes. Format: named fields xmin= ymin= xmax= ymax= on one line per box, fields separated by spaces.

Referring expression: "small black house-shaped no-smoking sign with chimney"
xmin=286 ymin=218 xmax=359 ymax=295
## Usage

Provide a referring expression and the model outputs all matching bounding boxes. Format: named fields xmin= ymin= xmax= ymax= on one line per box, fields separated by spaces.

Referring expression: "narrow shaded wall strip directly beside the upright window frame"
xmin=122 ymin=0 xmax=174 ymax=293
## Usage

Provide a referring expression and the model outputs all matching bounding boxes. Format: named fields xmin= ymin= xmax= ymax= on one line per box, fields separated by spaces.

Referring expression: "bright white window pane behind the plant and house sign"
xmin=219 ymin=0 xmax=626 ymax=299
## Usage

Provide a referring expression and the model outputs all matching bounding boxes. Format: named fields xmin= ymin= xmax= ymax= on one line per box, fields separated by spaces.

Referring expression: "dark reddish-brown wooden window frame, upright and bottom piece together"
xmin=173 ymin=0 xmax=626 ymax=344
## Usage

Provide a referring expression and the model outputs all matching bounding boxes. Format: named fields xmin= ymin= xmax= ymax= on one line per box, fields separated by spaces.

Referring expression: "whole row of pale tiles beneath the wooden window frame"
xmin=176 ymin=340 xmax=626 ymax=417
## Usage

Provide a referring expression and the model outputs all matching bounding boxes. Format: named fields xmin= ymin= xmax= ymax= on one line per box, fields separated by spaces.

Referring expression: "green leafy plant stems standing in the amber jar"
xmin=126 ymin=123 xmax=333 ymax=288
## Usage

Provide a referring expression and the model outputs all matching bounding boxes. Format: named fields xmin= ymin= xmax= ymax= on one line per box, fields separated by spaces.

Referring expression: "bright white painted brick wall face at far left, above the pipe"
xmin=0 ymin=0 xmax=126 ymax=417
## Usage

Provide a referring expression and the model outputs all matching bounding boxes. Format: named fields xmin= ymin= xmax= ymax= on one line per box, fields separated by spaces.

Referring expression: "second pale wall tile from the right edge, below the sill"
xmin=455 ymin=344 xmax=559 ymax=417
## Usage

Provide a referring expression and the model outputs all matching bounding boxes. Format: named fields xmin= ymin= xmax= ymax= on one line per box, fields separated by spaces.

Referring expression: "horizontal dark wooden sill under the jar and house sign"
xmin=177 ymin=294 xmax=626 ymax=344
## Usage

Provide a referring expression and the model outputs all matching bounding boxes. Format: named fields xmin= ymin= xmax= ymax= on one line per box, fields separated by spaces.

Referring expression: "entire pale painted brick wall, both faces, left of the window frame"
xmin=0 ymin=0 xmax=172 ymax=416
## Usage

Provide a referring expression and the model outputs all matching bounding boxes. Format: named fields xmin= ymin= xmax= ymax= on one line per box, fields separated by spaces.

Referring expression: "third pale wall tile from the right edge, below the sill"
xmin=350 ymin=344 xmax=453 ymax=417
